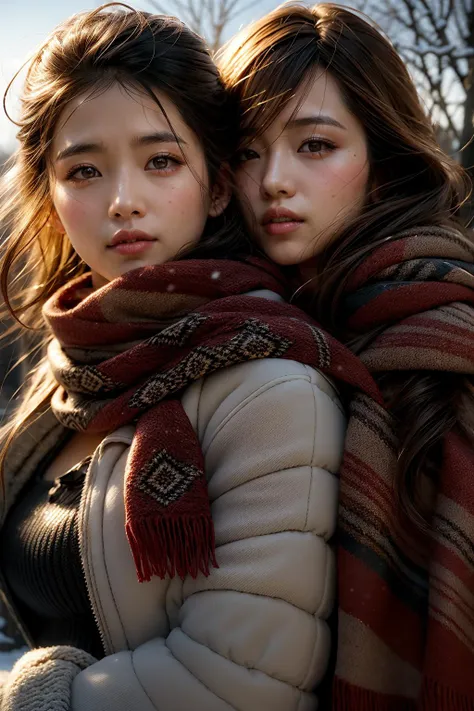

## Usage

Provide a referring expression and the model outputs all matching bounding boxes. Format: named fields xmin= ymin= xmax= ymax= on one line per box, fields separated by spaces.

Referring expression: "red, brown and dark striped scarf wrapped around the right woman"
xmin=333 ymin=228 xmax=474 ymax=711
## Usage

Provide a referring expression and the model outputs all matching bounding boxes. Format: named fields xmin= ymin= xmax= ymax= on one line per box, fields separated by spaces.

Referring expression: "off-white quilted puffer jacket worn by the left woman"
xmin=2 ymin=330 xmax=345 ymax=711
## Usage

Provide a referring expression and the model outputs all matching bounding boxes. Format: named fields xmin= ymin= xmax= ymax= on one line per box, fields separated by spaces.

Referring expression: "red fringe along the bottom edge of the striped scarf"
xmin=331 ymin=678 xmax=474 ymax=711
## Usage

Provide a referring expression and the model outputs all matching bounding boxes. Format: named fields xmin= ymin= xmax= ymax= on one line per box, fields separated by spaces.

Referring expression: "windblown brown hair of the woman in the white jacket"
xmin=0 ymin=3 xmax=250 ymax=472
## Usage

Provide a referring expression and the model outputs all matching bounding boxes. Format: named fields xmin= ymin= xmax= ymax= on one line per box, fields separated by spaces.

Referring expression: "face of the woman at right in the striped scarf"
xmin=236 ymin=71 xmax=369 ymax=265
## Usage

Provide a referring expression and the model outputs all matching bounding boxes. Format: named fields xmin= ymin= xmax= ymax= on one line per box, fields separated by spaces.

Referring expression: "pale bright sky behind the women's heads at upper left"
xmin=0 ymin=0 xmax=280 ymax=152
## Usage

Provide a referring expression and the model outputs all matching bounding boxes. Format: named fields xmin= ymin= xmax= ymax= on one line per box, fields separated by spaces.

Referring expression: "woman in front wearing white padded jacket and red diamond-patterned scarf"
xmin=0 ymin=5 xmax=360 ymax=711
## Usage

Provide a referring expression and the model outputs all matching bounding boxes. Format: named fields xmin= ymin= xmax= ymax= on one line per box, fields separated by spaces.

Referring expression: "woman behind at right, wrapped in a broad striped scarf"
xmin=221 ymin=4 xmax=474 ymax=711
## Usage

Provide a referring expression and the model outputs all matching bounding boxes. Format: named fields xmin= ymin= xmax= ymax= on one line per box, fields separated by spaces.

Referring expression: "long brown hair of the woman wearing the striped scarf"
xmin=219 ymin=3 xmax=474 ymax=525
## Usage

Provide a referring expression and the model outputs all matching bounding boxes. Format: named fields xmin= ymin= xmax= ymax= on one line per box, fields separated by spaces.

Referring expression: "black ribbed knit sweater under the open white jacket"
xmin=0 ymin=460 xmax=104 ymax=659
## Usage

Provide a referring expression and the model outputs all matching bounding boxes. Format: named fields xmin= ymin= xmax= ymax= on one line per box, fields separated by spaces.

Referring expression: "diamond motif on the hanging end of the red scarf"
xmin=136 ymin=450 xmax=202 ymax=506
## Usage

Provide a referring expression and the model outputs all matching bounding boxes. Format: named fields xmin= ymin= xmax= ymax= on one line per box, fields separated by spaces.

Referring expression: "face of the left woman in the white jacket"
xmin=51 ymin=84 xmax=228 ymax=286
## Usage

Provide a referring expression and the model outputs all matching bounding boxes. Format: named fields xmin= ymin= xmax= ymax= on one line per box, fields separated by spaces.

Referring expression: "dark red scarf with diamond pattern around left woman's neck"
xmin=44 ymin=260 xmax=380 ymax=581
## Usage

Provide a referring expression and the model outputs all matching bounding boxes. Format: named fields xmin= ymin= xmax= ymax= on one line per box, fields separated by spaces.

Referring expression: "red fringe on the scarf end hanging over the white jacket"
xmin=126 ymin=514 xmax=219 ymax=583
